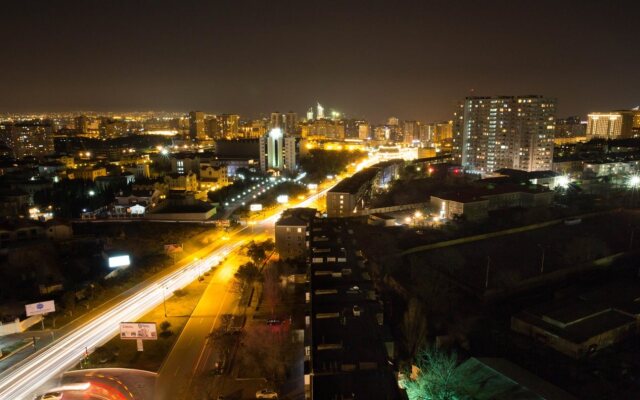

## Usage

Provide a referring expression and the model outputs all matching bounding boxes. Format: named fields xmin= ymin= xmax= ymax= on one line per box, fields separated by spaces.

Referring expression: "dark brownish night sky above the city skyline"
xmin=0 ymin=0 xmax=640 ymax=122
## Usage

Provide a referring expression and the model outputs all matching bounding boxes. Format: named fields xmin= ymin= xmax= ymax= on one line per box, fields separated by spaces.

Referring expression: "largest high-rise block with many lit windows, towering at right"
xmin=452 ymin=95 xmax=556 ymax=172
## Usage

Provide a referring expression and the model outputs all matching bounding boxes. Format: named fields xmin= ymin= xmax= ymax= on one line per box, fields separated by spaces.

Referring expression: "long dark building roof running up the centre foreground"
xmin=304 ymin=218 xmax=403 ymax=400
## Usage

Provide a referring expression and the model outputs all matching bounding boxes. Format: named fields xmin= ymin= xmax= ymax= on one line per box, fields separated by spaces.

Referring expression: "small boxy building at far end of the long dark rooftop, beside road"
xmin=275 ymin=208 xmax=317 ymax=259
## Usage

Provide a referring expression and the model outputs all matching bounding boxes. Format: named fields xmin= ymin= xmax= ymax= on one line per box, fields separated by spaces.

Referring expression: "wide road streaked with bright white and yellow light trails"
xmin=0 ymin=173 xmax=342 ymax=400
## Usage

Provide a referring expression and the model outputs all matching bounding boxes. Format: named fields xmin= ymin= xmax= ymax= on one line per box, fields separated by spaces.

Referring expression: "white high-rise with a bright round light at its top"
xmin=260 ymin=128 xmax=297 ymax=172
